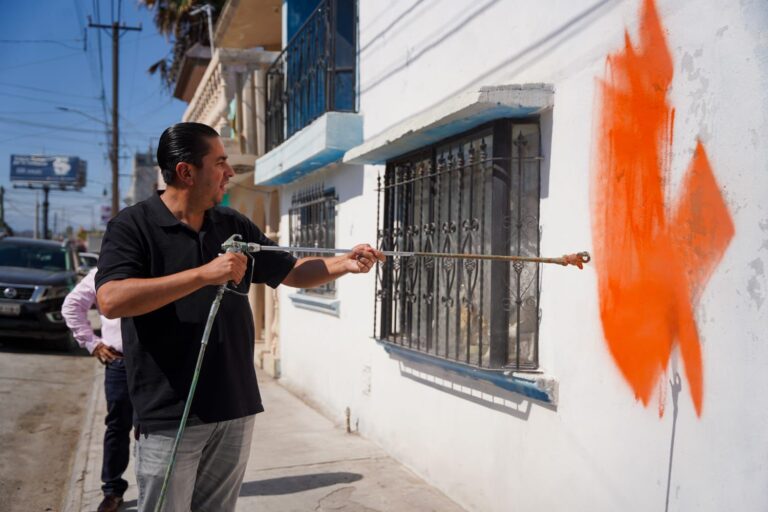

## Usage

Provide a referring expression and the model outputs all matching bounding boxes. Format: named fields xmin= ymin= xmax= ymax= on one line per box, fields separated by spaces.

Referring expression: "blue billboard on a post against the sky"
xmin=11 ymin=155 xmax=86 ymax=188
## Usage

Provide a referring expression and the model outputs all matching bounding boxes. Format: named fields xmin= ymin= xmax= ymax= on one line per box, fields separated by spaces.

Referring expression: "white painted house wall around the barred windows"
xmin=280 ymin=0 xmax=768 ymax=512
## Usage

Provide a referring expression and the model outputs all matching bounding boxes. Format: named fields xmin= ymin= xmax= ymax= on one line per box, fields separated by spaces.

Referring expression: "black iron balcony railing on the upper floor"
xmin=266 ymin=0 xmax=357 ymax=151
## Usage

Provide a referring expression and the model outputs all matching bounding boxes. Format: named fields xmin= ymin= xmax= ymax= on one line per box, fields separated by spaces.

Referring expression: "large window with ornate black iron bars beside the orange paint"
xmin=376 ymin=119 xmax=541 ymax=370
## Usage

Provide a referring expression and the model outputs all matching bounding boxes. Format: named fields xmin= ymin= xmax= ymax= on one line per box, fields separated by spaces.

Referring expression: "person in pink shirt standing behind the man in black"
xmin=61 ymin=268 xmax=133 ymax=512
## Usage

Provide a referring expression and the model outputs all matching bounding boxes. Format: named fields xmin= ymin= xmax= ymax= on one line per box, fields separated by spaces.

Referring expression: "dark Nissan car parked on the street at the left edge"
xmin=0 ymin=237 xmax=87 ymax=348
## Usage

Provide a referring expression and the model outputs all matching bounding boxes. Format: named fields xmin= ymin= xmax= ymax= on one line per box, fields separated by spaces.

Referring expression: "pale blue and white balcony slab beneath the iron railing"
xmin=254 ymin=112 xmax=363 ymax=185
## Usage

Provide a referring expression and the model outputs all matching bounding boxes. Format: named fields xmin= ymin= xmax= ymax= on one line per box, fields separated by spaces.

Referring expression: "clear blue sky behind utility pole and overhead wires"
xmin=0 ymin=0 xmax=186 ymax=231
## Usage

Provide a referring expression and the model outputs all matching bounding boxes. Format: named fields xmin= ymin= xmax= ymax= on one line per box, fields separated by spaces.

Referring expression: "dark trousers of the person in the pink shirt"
xmin=101 ymin=359 xmax=133 ymax=496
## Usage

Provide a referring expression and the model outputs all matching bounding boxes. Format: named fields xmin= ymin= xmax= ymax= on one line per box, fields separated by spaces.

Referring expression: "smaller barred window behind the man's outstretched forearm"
xmin=289 ymin=185 xmax=338 ymax=297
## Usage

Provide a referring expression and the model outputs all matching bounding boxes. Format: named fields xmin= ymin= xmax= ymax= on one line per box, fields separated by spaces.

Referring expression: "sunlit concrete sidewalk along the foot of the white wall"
xmin=64 ymin=368 xmax=463 ymax=512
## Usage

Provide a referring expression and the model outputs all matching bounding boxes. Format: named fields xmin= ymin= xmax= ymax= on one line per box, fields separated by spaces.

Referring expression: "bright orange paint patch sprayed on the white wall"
xmin=592 ymin=0 xmax=734 ymax=415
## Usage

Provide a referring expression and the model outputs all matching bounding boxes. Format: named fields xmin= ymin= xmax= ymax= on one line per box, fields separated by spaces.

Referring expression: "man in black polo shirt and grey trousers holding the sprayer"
xmin=96 ymin=123 xmax=384 ymax=511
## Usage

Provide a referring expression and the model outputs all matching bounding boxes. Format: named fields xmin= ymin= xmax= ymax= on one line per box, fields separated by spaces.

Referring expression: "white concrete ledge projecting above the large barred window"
xmin=344 ymin=84 xmax=554 ymax=164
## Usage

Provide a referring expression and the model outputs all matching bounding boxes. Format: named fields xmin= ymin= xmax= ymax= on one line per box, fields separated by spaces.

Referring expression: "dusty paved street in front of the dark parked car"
xmin=0 ymin=339 xmax=98 ymax=512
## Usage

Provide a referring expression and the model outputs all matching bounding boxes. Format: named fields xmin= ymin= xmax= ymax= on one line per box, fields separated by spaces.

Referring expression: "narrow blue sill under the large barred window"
xmin=379 ymin=340 xmax=554 ymax=404
